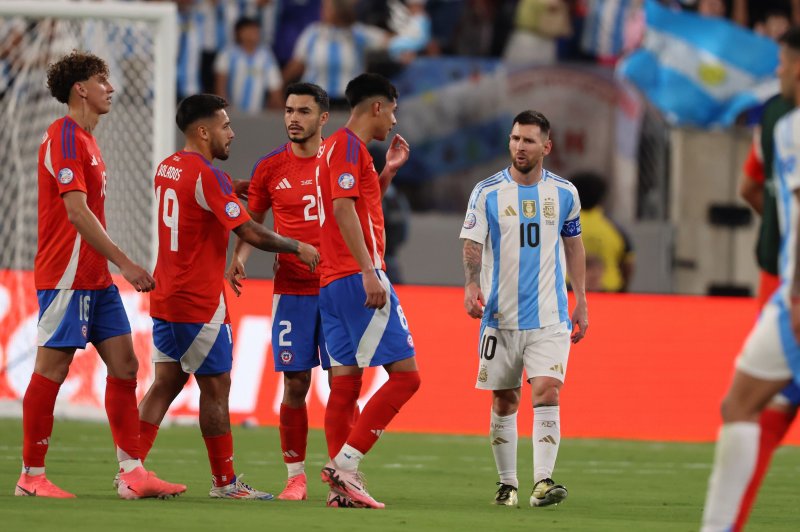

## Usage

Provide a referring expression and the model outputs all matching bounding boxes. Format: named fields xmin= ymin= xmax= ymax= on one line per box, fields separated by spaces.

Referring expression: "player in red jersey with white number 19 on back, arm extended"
xmin=139 ymin=94 xmax=319 ymax=500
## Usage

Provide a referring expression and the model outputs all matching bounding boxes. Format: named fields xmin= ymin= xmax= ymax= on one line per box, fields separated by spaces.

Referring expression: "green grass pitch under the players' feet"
xmin=0 ymin=419 xmax=800 ymax=532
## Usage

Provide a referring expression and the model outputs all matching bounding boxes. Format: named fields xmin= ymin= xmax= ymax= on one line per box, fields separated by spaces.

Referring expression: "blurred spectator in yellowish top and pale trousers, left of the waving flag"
xmin=503 ymin=0 xmax=572 ymax=65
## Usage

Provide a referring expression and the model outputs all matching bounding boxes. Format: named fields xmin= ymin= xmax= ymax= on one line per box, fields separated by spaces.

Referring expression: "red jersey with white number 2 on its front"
xmin=247 ymin=143 xmax=319 ymax=295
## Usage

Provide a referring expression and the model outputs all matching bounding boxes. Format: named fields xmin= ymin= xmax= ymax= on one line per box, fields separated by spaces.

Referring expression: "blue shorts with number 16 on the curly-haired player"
xmin=36 ymin=284 xmax=131 ymax=349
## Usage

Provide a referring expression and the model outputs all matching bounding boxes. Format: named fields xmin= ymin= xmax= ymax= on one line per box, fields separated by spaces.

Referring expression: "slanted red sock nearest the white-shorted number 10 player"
xmin=347 ymin=371 xmax=420 ymax=454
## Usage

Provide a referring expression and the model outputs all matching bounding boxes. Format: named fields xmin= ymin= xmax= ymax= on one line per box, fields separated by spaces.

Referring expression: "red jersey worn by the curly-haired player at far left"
xmin=33 ymin=116 xmax=111 ymax=290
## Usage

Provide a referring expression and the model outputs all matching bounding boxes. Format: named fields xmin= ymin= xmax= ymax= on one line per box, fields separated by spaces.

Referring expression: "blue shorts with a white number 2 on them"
xmin=272 ymin=294 xmax=331 ymax=371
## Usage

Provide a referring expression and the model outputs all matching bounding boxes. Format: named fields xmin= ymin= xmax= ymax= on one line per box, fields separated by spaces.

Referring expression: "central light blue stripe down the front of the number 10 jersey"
xmin=517 ymin=186 xmax=542 ymax=329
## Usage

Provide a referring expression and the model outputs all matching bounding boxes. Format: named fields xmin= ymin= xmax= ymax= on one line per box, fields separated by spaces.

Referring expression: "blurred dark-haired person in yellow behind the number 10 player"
xmin=571 ymin=172 xmax=634 ymax=292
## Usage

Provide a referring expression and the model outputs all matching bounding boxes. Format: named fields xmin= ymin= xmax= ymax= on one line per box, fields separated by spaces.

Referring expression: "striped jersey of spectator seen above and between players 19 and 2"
xmin=214 ymin=45 xmax=283 ymax=114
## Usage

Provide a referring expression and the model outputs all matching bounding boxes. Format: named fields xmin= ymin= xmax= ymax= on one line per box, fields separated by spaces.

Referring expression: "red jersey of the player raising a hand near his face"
xmin=318 ymin=128 xmax=386 ymax=286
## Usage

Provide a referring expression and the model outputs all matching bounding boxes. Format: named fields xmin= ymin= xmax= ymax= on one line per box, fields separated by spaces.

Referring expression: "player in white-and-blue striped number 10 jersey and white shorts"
xmin=461 ymin=111 xmax=589 ymax=506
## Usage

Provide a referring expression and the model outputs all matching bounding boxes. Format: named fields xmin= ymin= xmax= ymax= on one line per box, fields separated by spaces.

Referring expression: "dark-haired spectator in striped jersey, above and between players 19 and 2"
xmin=214 ymin=17 xmax=283 ymax=114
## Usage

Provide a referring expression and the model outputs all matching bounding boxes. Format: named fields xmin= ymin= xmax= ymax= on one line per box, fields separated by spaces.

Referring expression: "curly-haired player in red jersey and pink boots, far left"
xmin=15 ymin=52 xmax=186 ymax=499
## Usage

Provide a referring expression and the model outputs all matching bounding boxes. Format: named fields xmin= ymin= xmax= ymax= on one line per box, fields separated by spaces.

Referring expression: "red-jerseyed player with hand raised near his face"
xmin=318 ymin=74 xmax=420 ymax=508
